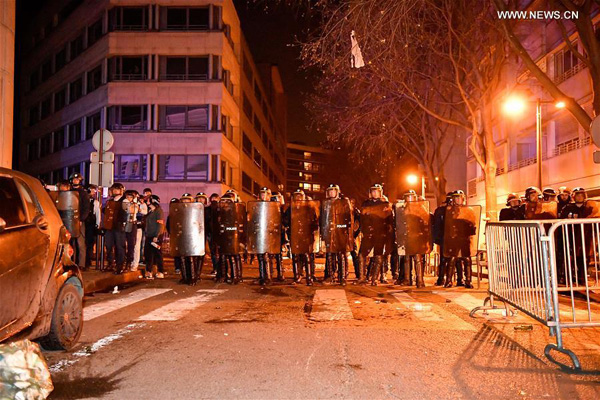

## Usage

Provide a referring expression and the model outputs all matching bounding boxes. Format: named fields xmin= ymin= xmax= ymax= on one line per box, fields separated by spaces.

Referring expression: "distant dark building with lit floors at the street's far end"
xmin=286 ymin=143 xmax=332 ymax=200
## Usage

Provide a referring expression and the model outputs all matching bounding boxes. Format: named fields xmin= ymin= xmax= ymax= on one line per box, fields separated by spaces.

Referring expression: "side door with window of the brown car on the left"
xmin=0 ymin=175 xmax=50 ymax=339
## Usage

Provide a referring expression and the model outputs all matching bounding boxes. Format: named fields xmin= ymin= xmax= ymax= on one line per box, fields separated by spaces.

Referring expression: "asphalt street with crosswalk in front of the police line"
xmin=45 ymin=264 xmax=600 ymax=400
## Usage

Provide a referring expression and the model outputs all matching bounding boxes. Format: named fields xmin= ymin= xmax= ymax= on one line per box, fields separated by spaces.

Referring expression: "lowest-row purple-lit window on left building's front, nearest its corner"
xmin=158 ymin=154 xmax=208 ymax=181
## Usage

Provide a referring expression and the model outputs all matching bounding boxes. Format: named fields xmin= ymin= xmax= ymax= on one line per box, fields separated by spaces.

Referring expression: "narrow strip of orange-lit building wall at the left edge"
xmin=0 ymin=0 xmax=16 ymax=168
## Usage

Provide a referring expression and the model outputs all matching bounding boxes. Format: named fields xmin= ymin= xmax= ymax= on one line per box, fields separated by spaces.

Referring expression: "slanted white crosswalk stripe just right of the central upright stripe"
xmin=388 ymin=290 xmax=476 ymax=331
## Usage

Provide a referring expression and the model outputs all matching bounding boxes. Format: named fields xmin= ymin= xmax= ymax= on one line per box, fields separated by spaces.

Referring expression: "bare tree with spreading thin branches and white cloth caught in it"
xmin=302 ymin=0 xmax=506 ymax=219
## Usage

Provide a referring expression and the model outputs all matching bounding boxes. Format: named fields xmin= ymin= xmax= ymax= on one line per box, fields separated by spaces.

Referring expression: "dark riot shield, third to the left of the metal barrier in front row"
xmin=360 ymin=200 xmax=394 ymax=256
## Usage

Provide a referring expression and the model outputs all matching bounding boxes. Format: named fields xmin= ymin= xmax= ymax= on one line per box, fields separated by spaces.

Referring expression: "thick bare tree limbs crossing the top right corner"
xmin=494 ymin=0 xmax=600 ymax=132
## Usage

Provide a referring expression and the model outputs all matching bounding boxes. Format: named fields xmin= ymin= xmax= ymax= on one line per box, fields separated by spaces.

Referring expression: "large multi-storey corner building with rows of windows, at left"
xmin=19 ymin=0 xmax=286 ymax=202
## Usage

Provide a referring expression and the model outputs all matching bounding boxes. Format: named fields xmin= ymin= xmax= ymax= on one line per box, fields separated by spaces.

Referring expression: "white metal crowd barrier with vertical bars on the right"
xmin=471 ymin=218 xmax=600 ymax=369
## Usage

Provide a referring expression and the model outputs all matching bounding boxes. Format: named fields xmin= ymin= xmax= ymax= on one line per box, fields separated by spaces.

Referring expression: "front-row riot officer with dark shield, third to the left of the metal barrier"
xmin=359 ymin=184 xmax=394 ymax=286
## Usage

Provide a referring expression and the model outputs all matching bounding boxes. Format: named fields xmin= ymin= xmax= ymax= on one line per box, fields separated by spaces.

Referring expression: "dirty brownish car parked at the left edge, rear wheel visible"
xmin=0 ymin=168 xmax=83 ymax=350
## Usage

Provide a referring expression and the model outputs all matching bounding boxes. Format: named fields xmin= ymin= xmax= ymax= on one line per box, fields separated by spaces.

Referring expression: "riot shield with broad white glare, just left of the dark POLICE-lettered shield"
xmin=169 ymin=203 xmax=205 ymax=257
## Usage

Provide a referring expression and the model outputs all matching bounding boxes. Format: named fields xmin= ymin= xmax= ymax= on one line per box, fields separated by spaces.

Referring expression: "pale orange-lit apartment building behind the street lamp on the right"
xmin=467 ymin=12 xmax=600 ymax=207
